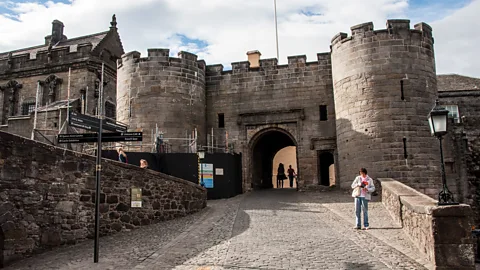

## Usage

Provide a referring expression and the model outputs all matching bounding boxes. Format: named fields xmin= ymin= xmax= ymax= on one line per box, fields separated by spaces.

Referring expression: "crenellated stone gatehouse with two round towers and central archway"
xmin=117 ymin=20 xmax=479 ymax=201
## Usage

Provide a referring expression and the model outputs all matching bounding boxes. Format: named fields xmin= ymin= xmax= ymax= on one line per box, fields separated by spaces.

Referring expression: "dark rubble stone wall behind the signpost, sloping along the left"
xmin=0 ymin=132 xmax=207 ymax=262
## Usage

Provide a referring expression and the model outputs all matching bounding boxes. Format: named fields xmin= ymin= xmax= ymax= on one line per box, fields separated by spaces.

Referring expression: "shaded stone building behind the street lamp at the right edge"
xmin=437 ymin=75 xmax=480 ymax=226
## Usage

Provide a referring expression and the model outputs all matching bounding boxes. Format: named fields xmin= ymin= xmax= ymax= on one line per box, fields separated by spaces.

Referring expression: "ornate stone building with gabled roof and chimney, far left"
xmin=0 ymin=15 xmax=124 ymax=144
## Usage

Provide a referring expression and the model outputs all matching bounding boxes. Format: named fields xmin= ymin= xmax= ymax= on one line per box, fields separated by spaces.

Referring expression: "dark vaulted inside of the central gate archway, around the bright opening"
xmin=246 ymin=126 xmax=298 ymax=189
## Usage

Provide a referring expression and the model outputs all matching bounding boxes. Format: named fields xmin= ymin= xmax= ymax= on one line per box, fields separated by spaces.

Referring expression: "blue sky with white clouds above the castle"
xmin=0 ymin=0 xmax=480 ymax=77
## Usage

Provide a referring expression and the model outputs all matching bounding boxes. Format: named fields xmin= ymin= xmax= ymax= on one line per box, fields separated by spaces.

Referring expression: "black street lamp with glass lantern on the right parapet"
xmin=428 ymin=100 xmax=458 ymax=205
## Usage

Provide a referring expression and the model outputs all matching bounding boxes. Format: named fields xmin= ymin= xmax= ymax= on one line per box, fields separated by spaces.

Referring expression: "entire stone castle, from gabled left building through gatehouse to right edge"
xmin=0 ymin=18 xmax=480 ymax=213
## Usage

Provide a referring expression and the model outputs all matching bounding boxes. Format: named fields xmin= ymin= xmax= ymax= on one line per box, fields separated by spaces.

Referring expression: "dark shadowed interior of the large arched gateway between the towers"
xmin=250 ymin=129 xmax=296 ymax=189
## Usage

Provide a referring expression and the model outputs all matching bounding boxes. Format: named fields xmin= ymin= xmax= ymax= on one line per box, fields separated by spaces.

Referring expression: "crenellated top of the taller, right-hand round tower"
xmin=331 ymin=19 xmax=433 ymax=48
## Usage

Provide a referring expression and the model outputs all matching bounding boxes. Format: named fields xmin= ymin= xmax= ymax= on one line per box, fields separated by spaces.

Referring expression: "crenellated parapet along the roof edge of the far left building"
xmin=0 ymin=43 xmax=92 ymax=73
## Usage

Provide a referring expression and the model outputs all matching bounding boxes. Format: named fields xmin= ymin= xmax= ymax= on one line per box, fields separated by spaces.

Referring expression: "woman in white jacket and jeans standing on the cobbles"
xmin=352 ymin=168 xmax=375 ymax=230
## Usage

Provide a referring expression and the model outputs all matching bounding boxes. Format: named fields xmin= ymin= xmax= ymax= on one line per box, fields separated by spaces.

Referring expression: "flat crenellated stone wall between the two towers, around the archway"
xmin=206 ymin=53 xmax=335 ymax=189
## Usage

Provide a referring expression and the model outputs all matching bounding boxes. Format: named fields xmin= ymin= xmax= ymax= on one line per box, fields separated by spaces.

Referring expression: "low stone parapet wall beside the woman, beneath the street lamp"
xmin=379 ymin=178 xmax=475 ymax=270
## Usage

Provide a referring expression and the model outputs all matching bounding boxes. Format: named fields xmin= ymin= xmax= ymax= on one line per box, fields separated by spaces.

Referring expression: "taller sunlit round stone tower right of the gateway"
xmin=331 ymin=20 xmax=440 ymax=196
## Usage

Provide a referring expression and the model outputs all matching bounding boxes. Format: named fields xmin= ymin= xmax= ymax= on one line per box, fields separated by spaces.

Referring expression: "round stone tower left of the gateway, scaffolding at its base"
xmin=117 ymin=49 xmax=206 ymax=152
